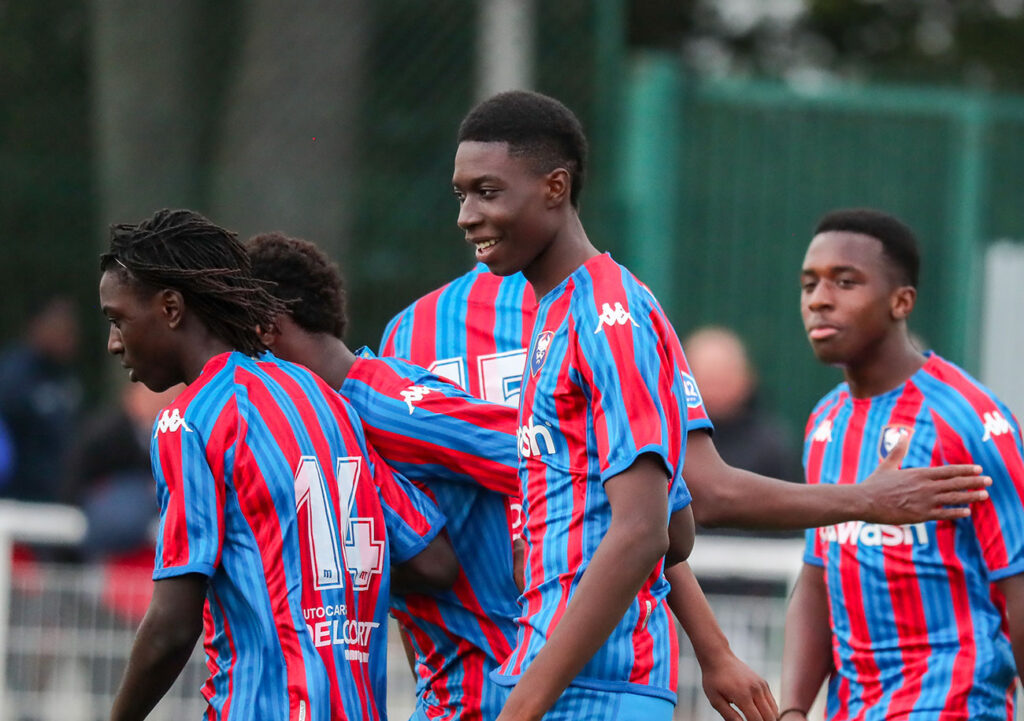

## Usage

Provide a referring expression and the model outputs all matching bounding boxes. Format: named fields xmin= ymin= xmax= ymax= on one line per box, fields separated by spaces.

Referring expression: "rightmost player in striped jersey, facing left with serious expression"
xmin=780 ymin=209 xmax=1024 ymax=721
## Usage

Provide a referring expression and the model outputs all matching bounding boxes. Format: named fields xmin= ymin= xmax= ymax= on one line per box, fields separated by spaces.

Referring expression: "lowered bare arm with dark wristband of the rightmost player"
xmin=778 ymin=563 xmax=833 ymax=721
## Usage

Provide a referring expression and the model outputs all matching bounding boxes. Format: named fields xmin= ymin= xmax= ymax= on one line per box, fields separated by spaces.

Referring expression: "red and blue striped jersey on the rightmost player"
xmin=804 ymin=353 xmax=1024 ymax=720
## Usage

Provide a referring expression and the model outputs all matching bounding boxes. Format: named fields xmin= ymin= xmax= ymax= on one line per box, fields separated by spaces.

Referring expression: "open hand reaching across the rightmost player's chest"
xmin=861 ymin=436 xmax=992 ymax=525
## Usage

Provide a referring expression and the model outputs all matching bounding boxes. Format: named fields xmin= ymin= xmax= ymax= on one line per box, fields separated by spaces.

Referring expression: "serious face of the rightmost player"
xmin=800 ymin=230 xmax=899 ymax=366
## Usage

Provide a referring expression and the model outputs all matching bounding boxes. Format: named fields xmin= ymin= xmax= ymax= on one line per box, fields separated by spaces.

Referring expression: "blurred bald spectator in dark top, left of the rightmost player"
xmin=683 ymin=326 xmax=803 ymax=489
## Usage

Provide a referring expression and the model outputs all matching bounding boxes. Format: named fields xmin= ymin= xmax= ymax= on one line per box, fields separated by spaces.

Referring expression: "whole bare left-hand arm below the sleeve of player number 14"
xmin=111 ymin=574 xmax=207 ymax=721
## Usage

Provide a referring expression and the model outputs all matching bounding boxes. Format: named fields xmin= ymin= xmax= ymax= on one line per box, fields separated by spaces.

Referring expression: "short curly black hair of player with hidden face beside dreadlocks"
xmin=246 ymin=232 xmax=347 ymax=338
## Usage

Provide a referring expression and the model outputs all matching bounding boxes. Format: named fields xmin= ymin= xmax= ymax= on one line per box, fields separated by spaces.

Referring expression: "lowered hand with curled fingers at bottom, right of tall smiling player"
xmin=700 ymin=651 xmax=778 ymax=721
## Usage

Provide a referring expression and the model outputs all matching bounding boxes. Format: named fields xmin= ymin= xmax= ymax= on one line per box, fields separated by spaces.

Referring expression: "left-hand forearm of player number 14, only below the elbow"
xmin=111 ymin=609 xmax=202 ymax=721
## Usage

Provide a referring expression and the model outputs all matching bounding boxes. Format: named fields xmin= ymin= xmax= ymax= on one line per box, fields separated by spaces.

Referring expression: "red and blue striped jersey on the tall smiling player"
xmin=493 ymin=254 xmax=710 ymax=702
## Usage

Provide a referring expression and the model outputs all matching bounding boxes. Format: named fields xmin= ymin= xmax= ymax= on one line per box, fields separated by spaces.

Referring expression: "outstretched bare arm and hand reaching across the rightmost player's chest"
xmin=683 ymin=430 xmax=991 ymax=531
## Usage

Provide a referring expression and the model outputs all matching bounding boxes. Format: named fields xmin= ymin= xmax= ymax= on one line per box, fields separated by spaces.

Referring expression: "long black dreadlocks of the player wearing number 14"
xmin=99 ymin=208 xmax=286 ymax=355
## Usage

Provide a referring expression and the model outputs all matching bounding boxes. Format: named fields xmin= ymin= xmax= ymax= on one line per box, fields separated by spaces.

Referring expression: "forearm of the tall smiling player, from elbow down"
xmin=499 ymin=518 xmax=669 ymax=721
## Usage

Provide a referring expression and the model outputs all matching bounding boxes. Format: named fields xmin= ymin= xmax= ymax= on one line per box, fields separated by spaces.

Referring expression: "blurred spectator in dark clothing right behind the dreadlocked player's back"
xmin=62 ymin=383 xmax=181 ymax=562
